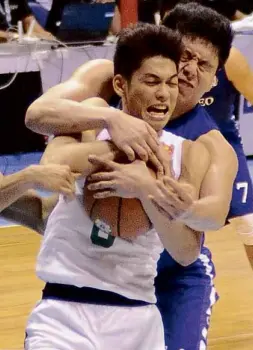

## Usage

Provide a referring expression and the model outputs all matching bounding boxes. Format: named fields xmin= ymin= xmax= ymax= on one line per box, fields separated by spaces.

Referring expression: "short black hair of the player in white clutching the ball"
xmin=114 ymin=23 xmax=183 ymax=80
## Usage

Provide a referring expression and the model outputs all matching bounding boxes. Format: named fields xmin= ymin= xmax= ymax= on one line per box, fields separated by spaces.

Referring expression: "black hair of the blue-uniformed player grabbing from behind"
xmin=163 ymin=2 xmax=234 ymax=67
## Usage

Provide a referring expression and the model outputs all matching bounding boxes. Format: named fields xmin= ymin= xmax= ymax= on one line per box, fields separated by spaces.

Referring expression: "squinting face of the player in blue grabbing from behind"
xmin=174 ymin=37 xmax=219 ymax=116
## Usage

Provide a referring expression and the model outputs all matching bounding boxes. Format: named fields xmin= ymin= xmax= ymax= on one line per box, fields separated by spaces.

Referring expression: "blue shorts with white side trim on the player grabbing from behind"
xmin=155 ymin=247 xmax=218 ymax=350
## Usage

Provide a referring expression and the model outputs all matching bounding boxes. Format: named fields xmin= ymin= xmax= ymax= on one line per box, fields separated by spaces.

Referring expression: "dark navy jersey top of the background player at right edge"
xmin=199 ymin=69 xmax=241 ymax=142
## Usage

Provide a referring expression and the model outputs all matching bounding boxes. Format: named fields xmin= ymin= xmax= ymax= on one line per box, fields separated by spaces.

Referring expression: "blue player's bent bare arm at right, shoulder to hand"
xmin=153 ymin=130 xmax=237 ymax=231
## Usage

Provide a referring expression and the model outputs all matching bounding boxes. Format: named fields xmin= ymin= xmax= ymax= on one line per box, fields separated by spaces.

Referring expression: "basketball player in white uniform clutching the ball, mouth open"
xmin=25 ymin=25 xmax=237 ymax=350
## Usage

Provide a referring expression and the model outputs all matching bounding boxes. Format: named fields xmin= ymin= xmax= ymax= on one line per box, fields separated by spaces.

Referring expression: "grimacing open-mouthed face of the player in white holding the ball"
xmin=114 ymin=56 xmax=178 ymax=131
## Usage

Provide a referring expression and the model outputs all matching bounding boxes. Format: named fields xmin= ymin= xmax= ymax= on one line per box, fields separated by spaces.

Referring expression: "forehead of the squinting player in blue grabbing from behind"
xmin=183 ymin=37 xmax=218 ymax=61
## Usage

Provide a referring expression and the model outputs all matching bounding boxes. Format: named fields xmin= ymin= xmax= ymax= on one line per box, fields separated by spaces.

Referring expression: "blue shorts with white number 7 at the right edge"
xmin=228 ymin=140 xmax=253 ymax=219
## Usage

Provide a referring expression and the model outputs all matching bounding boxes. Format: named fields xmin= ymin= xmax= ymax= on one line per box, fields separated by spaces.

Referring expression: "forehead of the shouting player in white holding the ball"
xmin=138 ymin=56 xmax=177 ymax=79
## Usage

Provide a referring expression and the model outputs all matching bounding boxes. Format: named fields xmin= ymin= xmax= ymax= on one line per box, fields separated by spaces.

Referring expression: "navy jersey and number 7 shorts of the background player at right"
xmin=200 ymin=70 xmax=253 ymax=218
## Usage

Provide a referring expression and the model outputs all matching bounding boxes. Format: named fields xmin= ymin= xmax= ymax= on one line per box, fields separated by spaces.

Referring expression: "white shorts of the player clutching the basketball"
xmin=25 ymin=299 xmax=165 ymax=350
